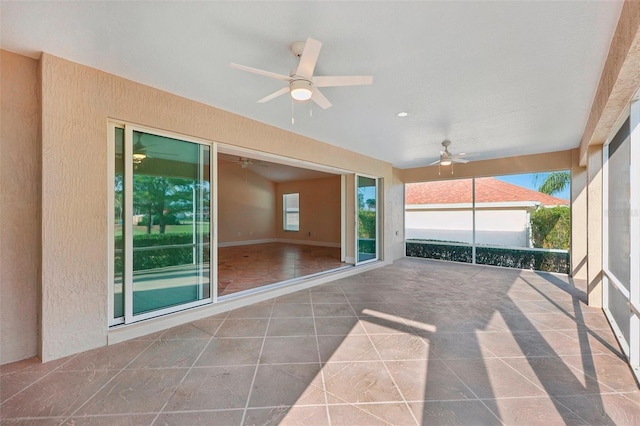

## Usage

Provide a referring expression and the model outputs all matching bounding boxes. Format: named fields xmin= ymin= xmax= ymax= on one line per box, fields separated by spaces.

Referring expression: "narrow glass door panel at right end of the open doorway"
xmin=356 ymin=176 xmax=378 ymax=263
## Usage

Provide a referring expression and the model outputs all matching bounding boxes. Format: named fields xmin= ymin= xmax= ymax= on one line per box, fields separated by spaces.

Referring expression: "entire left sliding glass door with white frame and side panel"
xmin=110 ymin=125 xmax=212 ymax=324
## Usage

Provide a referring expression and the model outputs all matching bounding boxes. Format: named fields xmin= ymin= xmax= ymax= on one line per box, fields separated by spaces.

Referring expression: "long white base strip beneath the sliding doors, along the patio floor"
xmin=107 ymin=262 xmax=387 ymax=345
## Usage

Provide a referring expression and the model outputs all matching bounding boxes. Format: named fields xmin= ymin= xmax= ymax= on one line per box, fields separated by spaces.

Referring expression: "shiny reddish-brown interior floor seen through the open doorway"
xmin=218 ymin=243 xmax=346 ymax=296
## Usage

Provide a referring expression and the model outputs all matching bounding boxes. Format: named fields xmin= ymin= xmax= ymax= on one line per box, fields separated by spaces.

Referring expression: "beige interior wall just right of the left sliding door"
xmin=218 ymin=163 xmax=276 ymax=246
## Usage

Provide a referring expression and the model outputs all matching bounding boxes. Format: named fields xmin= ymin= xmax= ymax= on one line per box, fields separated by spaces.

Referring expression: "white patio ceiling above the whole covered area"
xmin=0 ymin=1 xmax=622 ymax=168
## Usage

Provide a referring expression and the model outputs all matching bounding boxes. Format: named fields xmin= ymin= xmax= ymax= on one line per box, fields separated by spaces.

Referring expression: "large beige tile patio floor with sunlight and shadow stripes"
xmin=0 ymin=259 xmax=640 ymax=426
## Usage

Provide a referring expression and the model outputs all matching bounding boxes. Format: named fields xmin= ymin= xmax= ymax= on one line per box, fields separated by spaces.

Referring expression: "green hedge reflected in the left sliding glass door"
xmin=114 ymin=233 xmax=210 ymax=271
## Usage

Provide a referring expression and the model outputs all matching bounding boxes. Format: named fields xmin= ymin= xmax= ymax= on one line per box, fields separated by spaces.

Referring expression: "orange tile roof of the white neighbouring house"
xmin=405 ymin=177 xmax=569 ymax=206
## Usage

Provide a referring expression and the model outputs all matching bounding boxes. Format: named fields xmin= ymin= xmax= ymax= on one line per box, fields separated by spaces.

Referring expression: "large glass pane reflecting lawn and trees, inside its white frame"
xmin=132 ymin=131 xmax=211 ymax=315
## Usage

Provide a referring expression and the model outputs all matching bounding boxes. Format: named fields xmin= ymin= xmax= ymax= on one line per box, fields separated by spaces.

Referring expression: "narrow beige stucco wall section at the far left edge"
xmin=0 ymin=50 xmax=41 ymax=364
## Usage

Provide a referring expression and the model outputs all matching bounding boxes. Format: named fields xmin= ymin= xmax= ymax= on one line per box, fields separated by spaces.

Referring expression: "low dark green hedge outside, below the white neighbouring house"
xmin=406 ymin=241 xmax=569 ymax=274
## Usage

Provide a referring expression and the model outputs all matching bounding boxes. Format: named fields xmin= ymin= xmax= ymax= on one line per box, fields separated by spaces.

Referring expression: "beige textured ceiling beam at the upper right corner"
xmin=580 ymin=0 xmax=640 ymax=167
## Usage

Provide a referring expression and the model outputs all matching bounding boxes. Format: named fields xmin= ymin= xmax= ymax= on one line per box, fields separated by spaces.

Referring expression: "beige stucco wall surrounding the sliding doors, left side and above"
xmin=40 ymin=53 xmax=392 ymax=360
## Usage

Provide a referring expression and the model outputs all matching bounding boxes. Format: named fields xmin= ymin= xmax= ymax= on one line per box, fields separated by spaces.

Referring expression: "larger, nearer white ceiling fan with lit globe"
xmin=231 ymin=38 xmax=373 ymax=109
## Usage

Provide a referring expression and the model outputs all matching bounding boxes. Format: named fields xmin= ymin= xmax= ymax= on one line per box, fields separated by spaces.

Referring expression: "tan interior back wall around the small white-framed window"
xmin=274 ymin=175 xmax=341 ymax=247
